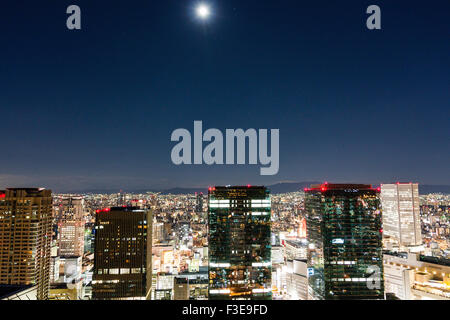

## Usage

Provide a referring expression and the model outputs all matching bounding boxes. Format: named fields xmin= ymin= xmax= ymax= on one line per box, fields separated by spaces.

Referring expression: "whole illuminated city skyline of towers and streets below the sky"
xmin=0 ymin=182 xmax=450 ymax=301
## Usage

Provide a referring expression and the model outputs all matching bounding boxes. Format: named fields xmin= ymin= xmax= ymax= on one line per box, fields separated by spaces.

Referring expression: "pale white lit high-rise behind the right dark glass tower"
xmin=381 ymin=183 xmax=422 ymax=246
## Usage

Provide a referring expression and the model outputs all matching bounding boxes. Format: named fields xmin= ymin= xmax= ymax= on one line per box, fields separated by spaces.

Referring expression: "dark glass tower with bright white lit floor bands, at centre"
xmin=208 ymin=186 xmax=272 ymax=300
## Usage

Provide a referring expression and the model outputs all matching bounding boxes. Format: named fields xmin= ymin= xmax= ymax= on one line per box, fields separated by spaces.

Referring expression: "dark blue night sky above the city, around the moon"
xmin=0 ymin=0 xmax=450 ymax=191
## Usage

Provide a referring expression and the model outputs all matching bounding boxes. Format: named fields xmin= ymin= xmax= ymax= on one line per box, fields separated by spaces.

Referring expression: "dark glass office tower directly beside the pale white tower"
xmin=305 ymin=183 xmax=384 ymax=299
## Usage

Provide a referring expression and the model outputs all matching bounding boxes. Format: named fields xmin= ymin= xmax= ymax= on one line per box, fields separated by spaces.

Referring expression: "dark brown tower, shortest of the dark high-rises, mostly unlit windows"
xmin=92 ymin=207 xmax=152 ymax=300
